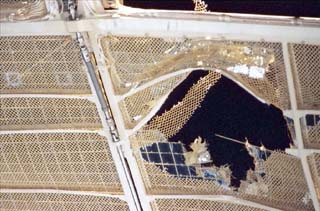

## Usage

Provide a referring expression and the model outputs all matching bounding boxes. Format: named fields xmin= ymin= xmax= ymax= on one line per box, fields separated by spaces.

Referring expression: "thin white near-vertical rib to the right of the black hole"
xmin=282 ymin=42 xmax=320 ymax=211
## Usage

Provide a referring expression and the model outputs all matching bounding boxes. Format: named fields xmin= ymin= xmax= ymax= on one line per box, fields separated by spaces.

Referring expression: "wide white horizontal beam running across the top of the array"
xmin=0 ymin=11 xmax=320 ymax=44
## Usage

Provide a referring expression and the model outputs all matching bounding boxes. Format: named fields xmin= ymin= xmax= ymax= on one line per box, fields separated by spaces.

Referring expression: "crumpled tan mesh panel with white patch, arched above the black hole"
xmin=100 ymin=36 xmax=282 ymax=107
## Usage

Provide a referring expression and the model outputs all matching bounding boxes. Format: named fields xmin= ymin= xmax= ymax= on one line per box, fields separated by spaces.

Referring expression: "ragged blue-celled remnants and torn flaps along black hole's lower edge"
xmin=140 ymin=137 xmax=270 ymax=195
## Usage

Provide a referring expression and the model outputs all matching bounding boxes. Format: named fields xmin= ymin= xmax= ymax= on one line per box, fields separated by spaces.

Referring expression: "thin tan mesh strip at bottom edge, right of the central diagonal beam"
xmin=151 ymin=199 xmax=266 ymax=211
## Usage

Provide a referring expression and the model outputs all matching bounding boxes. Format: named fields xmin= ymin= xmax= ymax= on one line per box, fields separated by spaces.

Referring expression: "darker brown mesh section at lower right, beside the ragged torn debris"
xmin=240 ymin=151 xmax=314 ymax=211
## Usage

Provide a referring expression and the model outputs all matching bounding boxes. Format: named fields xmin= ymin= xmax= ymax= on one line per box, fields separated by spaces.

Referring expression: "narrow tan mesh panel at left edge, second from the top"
xmin=0 ymin=97 xmax=102 ymax=130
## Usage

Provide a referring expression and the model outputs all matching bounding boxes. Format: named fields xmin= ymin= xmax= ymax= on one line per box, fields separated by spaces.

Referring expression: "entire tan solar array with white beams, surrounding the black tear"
xmin=0 ymin=0 xmax=320 ymax=211
